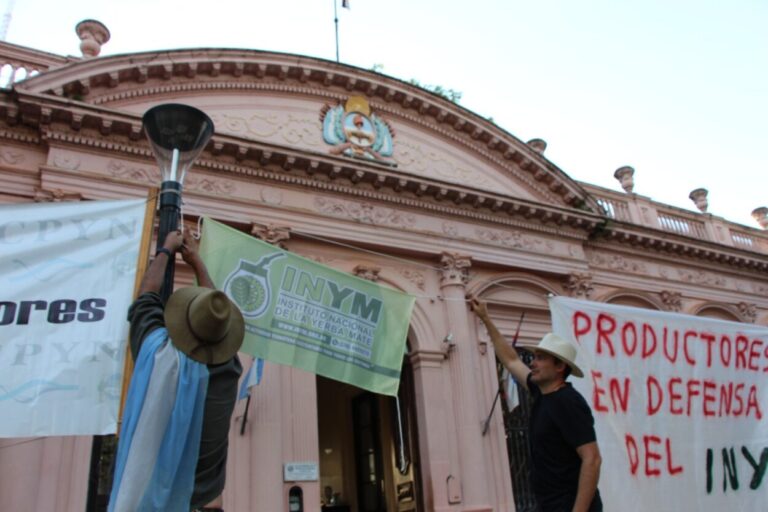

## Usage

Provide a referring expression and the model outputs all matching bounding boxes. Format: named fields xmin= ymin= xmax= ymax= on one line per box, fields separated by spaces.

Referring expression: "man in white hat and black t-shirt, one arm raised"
xmin=469 ymin=297 xmax=603 ymax=512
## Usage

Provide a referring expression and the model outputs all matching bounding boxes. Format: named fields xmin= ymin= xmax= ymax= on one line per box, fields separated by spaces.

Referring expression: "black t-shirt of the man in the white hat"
xmin=527 ymin=374 xmax=603 ymax=512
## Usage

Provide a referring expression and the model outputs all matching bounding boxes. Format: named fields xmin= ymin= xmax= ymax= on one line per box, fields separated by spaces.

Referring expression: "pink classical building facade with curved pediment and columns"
xmin=0 ymin=25 xmax=768 ymax=512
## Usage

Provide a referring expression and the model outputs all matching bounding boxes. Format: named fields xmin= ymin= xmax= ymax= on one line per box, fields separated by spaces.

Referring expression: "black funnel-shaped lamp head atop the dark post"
xmin=142 ymin=103 xmax=213 ymax=184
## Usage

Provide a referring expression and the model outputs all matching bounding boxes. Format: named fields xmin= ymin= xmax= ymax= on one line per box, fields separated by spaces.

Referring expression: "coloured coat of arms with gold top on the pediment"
xmin=320 ymin=96 xmax=395 ymax=165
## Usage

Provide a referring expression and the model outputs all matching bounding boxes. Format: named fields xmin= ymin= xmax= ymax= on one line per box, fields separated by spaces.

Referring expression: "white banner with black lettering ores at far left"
xmin=0 ymin=200 xmax=146 ymax=437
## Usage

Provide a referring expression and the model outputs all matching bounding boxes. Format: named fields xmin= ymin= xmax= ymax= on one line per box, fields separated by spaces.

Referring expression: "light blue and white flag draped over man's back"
xmin=108 ymin=329 xmax=208 ymax=512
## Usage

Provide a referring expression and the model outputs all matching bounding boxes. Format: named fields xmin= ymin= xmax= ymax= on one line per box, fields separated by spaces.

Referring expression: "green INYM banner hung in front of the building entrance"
xmin=200 ymin=218 xmax=415 ymax=396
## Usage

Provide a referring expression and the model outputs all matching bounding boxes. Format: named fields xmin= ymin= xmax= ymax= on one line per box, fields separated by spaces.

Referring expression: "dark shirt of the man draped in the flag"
xmin=128 ymin=292 xmax=243 ymax=508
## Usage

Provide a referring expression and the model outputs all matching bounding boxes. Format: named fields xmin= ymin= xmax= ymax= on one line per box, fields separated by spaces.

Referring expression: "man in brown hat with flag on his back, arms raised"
xmin=109 ymin=232 xmax=244 ymax=512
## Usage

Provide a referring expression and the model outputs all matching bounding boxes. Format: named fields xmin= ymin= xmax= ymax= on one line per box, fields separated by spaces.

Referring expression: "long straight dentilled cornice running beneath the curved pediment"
xmin=0 ymin=87 xmax=768 ymax=270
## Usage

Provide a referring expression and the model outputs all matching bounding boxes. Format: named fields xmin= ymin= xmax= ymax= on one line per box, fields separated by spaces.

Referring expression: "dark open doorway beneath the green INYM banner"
xmin=317 ymin=348 xmax=424 ymax=512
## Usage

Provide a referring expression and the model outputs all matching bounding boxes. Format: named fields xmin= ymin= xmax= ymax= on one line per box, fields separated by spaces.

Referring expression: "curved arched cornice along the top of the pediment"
xmin=12 ymin=49 xmax=600 ymax=213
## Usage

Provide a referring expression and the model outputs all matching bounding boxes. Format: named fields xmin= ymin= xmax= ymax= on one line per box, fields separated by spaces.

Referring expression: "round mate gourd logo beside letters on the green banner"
xmin=224 ymin=252 xmax=285 ymax=318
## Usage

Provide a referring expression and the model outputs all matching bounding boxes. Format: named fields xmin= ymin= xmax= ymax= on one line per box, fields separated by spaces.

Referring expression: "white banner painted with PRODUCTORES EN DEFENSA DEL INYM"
xmin=549 ymin=297 xmax=768 ymax=512
